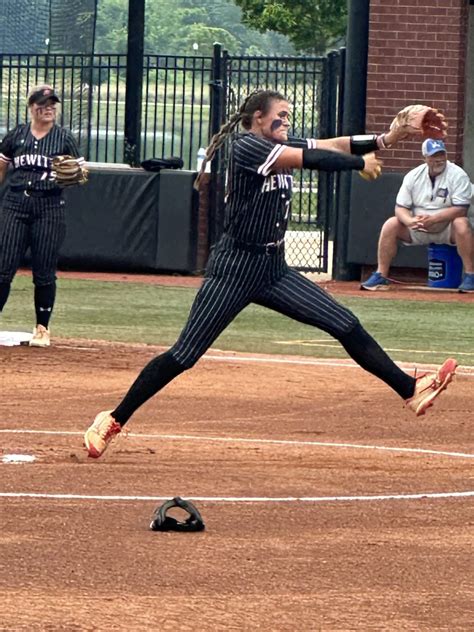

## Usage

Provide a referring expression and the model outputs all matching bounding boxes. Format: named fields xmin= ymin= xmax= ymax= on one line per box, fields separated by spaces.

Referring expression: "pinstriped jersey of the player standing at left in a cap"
xmin=0 ymin=123 xmax=80 ymax=191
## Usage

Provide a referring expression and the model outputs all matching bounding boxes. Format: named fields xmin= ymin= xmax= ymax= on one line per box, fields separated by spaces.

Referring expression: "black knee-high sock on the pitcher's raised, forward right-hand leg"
xmin=339 ymin=324 xmax=416 ymax=399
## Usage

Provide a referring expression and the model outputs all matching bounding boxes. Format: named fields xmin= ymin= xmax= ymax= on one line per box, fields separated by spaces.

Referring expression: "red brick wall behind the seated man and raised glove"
xmin=366 ymin=0 xmax=469 ymax=171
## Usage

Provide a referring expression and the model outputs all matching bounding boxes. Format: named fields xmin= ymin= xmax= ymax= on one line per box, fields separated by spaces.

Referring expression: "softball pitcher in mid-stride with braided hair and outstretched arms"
xmin=84 ymin=91 xmax=456 ymax=458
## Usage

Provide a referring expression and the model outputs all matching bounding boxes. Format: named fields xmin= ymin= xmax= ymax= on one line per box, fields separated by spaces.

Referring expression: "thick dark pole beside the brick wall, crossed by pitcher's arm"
xmin=333 ymin=0 xmax=370 ymax=281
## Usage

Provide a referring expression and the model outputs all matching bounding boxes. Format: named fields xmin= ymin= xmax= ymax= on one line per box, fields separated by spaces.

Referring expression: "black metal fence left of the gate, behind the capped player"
xmin=0 ymin=54 xmax=212 ymax=168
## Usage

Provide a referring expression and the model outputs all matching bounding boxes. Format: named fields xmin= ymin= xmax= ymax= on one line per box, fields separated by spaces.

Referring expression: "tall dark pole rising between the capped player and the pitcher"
xmin=124 ymin=0 xmax=145 ymax=167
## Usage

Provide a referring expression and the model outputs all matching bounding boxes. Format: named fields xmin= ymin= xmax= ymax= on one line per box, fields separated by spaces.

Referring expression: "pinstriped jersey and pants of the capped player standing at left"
xmin=0 ymin=124 xmax=79 ymax=286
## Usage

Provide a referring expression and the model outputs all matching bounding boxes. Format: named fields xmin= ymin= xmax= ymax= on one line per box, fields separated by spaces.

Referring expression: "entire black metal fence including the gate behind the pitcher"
xmin=0 ymin=45 xmax=344 ymax=271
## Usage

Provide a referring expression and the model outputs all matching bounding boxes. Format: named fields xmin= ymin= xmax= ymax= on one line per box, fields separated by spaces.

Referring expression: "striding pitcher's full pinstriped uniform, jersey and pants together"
xmin=170 ymin=133 xmax=358 ymax=368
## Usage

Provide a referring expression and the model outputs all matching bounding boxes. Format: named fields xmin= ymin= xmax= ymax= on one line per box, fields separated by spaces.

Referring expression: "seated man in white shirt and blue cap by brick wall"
xmin=361 ymin=139 xmax=474 ymax=292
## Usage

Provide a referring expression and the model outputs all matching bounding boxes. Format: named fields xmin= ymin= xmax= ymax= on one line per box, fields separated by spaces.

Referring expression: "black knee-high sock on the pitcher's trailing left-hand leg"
xmin=112 ymin=351 xmax=186 ymax=426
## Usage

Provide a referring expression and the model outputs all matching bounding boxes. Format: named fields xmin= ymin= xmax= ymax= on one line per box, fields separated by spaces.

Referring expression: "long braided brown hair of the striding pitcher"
xmin=194 ymin=90 xmax=286 ymax=190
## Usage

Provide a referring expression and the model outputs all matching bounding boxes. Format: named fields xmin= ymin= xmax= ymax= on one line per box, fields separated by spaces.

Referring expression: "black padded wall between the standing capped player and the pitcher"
xmin=0 ymin=168 xmax=199 ymax=273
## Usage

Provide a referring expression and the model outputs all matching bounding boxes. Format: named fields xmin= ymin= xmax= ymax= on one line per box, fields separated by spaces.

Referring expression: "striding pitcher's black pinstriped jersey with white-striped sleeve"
xmin=224 ymin=132 xmax=316 ymax=244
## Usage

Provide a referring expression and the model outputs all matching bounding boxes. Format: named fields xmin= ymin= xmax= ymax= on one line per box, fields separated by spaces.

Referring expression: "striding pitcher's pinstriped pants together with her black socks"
xmin=113 ymin=250 xmax=415 ymax=425
